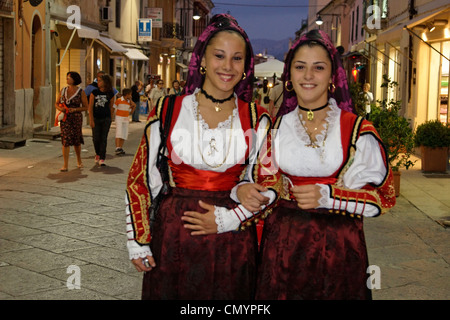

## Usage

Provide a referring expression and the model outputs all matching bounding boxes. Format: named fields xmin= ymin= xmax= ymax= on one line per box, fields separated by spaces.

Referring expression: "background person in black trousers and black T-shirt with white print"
xmin=89 ymin=74 xmax=115 ymax=166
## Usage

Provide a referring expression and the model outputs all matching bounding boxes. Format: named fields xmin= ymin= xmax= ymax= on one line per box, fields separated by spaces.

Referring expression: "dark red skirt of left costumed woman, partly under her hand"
xmin=142 ymin=188 xmax=257 ymax=300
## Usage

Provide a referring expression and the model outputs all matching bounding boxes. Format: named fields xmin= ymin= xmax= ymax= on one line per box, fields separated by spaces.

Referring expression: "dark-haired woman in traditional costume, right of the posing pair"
xmin=251 ymin=30 xmax=395 ymax=299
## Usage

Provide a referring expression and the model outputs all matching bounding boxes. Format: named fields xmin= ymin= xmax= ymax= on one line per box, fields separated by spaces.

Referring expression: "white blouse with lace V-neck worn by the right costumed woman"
xmin=227 ymin=98 xmax=387 ymax=232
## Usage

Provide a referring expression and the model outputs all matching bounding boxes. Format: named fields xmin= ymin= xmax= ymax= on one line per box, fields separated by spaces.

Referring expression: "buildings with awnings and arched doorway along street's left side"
xmin=0 ymin=0 xmax=214 ymax=139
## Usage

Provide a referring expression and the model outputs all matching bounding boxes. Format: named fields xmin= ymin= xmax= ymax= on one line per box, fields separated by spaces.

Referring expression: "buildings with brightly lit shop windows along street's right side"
xmin=308 ymin=0 xmax=450 ymax=128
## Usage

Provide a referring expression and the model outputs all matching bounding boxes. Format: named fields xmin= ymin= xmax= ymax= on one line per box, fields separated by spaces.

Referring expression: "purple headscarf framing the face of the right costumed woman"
xmin=278 ymin=30 xmax=354 ymax=116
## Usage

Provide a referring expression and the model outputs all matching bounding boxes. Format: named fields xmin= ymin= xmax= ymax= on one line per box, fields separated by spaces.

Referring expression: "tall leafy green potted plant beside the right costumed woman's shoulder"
xmin=362 ymin=76 xmax=416 ymax=196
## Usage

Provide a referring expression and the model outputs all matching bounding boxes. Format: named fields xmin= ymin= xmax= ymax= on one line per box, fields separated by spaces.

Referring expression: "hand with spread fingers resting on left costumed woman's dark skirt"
xmin=181 ymin=200 xmax=217 ymax=236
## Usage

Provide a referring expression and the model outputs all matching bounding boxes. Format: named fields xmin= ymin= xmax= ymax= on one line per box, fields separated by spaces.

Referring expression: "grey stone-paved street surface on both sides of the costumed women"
xmin=0 ymin=117 xmax=450 ymax=300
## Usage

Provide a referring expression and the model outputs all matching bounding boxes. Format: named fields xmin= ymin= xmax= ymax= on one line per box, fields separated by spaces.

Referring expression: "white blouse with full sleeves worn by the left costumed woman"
xmin=125 ymin=89 xmax=270 ymax=259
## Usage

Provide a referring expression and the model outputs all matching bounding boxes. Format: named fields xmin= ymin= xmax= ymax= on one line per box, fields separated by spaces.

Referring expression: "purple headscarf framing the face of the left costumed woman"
xmin=183 ymin=14 xmax=254 ymax=102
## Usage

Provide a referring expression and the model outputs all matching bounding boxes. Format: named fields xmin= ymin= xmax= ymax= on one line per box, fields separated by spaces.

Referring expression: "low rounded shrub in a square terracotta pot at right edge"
xmin=414 ymin=120 xmax=450 ymax=172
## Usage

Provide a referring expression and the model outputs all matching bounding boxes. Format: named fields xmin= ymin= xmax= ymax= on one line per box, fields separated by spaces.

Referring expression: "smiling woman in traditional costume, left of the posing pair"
xmin=126 ymin=14 xmax=271 ymax=300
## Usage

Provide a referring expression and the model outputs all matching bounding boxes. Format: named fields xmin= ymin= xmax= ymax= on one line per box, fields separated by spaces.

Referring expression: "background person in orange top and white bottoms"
xmin=114 ymin=88 xmax=136 ymax=155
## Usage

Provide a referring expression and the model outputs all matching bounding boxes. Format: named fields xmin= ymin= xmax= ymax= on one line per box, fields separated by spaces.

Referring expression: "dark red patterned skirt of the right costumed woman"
xmin=256 ymin=200 xmax=371 ymax=300
